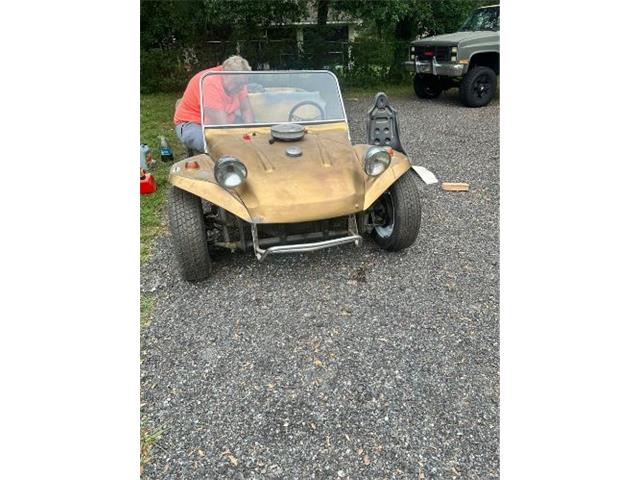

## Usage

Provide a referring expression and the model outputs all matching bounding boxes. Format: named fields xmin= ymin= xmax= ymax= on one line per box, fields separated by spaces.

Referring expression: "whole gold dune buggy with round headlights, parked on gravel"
xmin=169 ymin=71 xmax=437 ymax=280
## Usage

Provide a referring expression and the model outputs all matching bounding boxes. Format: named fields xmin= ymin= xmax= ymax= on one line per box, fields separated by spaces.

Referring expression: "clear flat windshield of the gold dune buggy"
xmin=200 ymin=70 xmax=345 ymax=127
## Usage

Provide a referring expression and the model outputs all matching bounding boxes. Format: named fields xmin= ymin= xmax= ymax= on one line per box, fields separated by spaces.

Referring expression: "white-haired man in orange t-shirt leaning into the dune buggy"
xmin=173 ymin=55 xmax=253 ymax=153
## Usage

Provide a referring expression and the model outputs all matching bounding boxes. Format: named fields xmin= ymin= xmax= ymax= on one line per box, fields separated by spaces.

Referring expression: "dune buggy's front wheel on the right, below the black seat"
xmin=373 ymin=171 xmax=421 ymax=252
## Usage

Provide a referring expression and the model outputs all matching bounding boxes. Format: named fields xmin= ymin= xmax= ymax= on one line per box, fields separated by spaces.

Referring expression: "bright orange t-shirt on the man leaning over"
xmin=173 ymin=65 xmax=248 ymax=125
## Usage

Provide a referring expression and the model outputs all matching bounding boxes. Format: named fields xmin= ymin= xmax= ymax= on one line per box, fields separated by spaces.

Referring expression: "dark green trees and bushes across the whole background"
xmin=140 ymin=0 xmax=497 ymax=93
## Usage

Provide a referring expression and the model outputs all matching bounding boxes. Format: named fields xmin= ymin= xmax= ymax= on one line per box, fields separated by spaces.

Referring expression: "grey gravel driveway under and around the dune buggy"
xmin=141 ymin=90 xmax=500 ymax=479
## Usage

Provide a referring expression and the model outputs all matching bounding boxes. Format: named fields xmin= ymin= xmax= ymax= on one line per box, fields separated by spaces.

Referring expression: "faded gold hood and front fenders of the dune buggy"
xmin=169 ymin=122 xmax=411 ymax=223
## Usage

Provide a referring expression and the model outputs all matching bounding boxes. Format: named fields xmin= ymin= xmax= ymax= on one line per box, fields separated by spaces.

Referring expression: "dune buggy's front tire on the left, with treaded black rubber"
xmin=169 ymin=187 xmax=211 ymax=282
